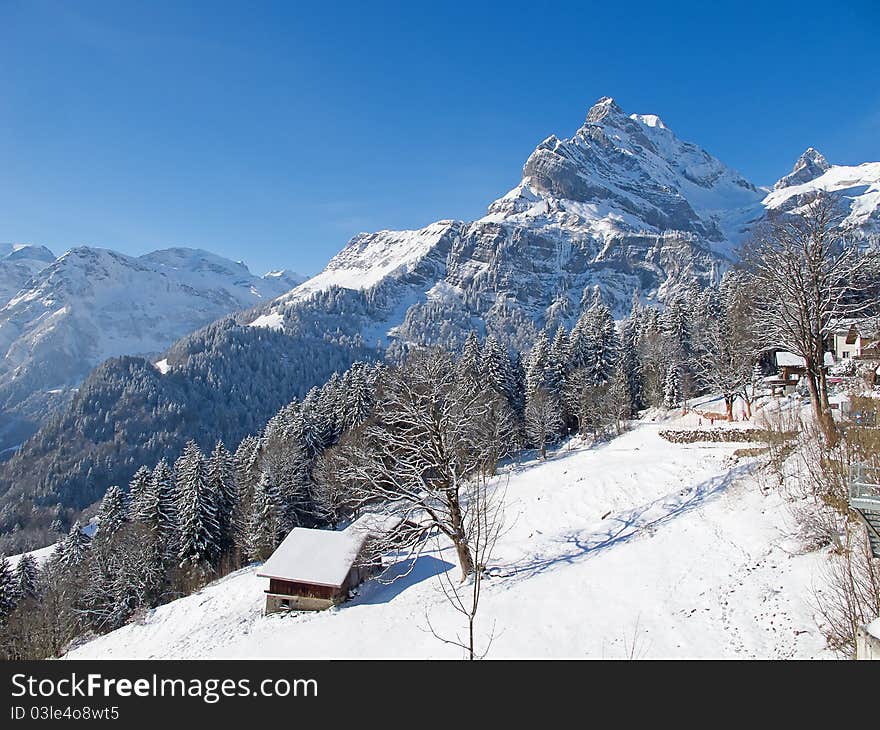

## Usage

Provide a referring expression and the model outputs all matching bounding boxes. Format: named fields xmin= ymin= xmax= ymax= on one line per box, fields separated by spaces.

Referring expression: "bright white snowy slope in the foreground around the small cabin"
xmin=68 ymin=420 xmax=833 ymax=659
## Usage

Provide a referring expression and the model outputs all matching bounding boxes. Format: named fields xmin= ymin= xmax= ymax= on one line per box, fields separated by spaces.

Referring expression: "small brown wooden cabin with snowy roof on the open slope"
xmin=257 ymin=515 xmax=400 ymax=614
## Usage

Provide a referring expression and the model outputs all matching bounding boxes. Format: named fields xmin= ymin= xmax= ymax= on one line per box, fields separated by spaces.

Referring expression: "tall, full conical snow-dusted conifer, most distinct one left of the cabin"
xmin=176 ymin=441 xmax=221 ymax=571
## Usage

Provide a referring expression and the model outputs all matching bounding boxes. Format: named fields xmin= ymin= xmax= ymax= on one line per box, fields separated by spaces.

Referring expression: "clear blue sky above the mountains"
xmin=0 ymin=0 xmax=880 ymax=273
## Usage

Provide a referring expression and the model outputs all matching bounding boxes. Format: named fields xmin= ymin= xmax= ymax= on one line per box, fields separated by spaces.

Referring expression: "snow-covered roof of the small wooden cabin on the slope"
xmin=257 ymin=513 xmax=400 ymax=588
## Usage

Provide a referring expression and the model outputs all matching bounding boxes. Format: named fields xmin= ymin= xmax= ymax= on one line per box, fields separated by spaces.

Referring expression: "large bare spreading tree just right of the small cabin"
xmin=316 ymin=351 xmax=515 ymax=580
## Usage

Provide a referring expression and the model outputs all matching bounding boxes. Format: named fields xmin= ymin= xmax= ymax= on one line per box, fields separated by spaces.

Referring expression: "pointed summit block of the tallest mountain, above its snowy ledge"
xmin=483 ymin=97 xmax=762 ymax=256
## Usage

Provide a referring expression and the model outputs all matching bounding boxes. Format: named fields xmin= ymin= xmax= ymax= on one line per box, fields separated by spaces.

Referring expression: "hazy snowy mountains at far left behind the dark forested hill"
xmin=0 ymin=246 xmax=302 ymax=424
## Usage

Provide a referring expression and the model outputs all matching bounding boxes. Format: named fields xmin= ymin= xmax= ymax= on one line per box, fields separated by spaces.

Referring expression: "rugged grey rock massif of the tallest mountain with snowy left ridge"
xmin=262 ymin=98 xmax=763 ymax=348
